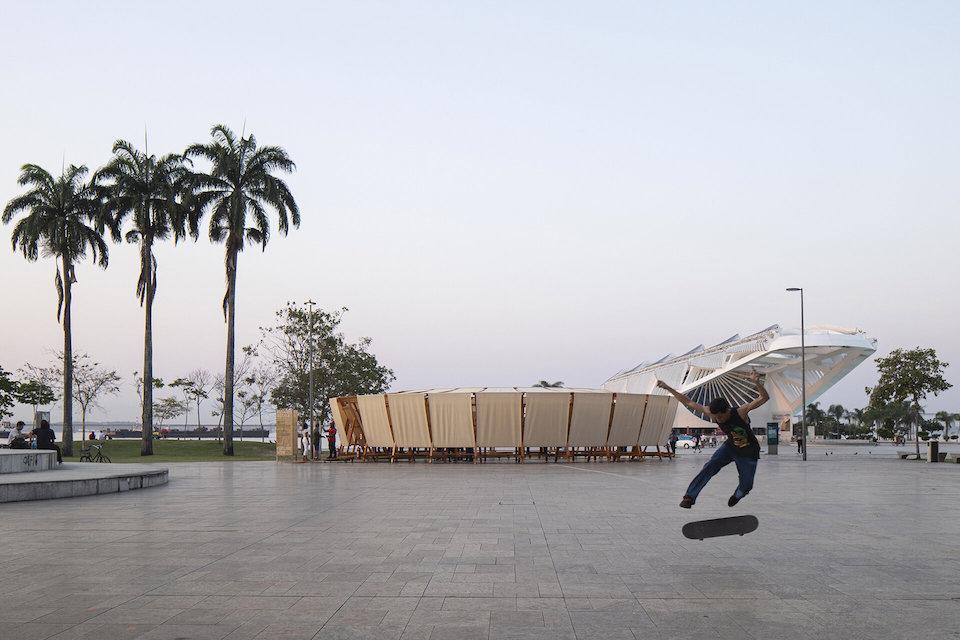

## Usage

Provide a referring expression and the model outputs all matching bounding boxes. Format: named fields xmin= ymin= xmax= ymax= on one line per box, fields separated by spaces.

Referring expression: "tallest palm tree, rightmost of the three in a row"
xmin=184 ymin=124 xmax=300 ymax=456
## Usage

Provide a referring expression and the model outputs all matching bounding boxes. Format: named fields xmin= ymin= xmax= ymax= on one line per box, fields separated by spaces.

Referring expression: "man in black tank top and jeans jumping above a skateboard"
xmin=657 ymin=371 xmax=770 ymax=509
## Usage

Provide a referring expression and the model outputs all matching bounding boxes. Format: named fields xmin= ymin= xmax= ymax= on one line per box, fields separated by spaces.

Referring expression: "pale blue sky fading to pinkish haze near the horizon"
xmin=0 ymin=0 xmax=960 ymax=420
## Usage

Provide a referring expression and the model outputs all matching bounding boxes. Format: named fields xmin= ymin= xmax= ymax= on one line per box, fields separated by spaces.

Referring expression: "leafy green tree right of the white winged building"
xmin=866 ymin=347 xmax=953 ymax=456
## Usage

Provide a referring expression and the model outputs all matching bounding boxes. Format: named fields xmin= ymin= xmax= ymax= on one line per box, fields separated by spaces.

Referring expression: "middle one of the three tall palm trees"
xmin=93 ymin=140 xmax=200 ymax=456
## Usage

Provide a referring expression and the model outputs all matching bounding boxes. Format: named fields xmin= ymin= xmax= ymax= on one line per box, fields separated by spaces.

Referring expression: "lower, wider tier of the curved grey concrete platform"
xmin=0 ymin=469 xmax=170 ymax=503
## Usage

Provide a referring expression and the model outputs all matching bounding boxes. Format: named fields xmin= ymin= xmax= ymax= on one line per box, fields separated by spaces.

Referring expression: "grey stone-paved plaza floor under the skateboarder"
xmin=0 ymin=447 xmax=960 ymax=640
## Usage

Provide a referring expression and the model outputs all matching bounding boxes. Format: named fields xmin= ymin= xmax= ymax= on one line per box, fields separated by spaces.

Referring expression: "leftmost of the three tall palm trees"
xmin=3 ymin=164 xmax=109 ymax=456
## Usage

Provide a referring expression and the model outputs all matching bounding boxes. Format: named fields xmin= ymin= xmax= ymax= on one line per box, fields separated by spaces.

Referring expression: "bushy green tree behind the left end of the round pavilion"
xmin=260 ymin=302 xmax=395 ymax=423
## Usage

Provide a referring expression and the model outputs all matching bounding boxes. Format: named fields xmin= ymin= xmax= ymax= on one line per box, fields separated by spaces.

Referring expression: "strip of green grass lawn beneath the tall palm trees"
xmin=63 ymin=440 xmax=276 ymax=462
